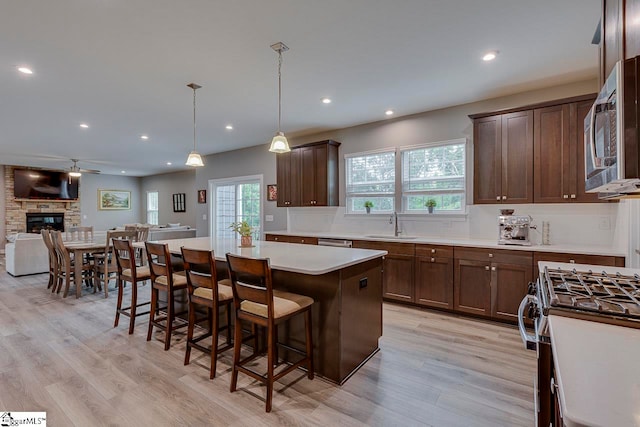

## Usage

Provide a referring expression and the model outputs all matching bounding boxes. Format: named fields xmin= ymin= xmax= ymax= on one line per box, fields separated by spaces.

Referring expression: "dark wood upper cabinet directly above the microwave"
xmin=600 ymin=0 xmax=640 ymax=84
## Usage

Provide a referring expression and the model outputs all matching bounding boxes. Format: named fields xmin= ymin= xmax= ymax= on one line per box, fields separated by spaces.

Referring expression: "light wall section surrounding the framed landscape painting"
xmin=80 ymin=173 xmax=142 ymax=230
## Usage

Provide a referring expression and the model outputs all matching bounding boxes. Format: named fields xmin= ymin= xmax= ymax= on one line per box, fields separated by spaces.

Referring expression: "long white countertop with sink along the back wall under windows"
xmin=265 ymin=231 xmax=626 ymax=257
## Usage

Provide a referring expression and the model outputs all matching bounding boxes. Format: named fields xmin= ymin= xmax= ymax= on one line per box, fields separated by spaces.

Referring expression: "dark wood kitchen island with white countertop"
xmin=141 ymin=237 xmax=387 ymax=384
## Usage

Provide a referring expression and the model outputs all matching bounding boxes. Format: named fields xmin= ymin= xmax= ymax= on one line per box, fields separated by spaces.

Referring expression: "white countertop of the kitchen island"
xmin=139 ymin=237 xmax=387 ymax=275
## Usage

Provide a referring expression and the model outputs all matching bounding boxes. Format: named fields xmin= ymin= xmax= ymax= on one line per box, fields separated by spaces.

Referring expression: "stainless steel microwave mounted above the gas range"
xmin=584 ymin=57 xmax=640 ymax=198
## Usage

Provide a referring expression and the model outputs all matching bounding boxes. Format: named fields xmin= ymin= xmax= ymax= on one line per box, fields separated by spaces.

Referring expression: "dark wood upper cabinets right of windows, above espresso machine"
xmin=470 ymin=95 xmax=599 ymax=204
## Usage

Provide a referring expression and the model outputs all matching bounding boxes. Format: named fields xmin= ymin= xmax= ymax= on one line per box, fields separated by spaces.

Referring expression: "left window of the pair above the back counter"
xmin=345 ymin=150 xmax=396 ymax=213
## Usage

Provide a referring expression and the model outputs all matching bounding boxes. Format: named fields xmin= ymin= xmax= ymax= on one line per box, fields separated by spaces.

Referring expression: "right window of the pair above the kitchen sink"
xmin=401 ymin=139 xmax=466 ymax=213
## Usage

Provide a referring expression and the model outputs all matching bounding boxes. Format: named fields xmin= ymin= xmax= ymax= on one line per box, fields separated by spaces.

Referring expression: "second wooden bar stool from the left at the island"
xmin=145 ymin=242 xmax=188 ymax=350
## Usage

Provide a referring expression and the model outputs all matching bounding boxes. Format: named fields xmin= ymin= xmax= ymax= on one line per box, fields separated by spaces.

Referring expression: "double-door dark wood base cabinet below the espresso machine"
xmin=454 ymin=247 xmax=534 ymax=321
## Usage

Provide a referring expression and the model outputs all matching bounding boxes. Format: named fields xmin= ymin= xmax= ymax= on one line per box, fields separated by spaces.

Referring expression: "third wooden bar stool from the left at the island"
xmin=180 ymin=247 xmax=233 ymax=379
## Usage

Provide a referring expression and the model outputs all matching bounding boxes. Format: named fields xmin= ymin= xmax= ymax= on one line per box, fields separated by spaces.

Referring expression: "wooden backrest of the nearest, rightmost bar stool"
xmin=227 ymin=253 xmax=274 ymax=319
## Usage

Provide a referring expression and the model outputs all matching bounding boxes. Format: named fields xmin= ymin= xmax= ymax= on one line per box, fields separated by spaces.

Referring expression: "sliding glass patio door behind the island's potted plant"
xmin=211 ymin=177 xmax=262 ymax=239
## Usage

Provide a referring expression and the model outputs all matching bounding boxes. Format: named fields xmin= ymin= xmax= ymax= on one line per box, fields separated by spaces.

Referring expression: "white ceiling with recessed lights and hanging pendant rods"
xmin=0 ymin=0 xmax=600 ymax=176
